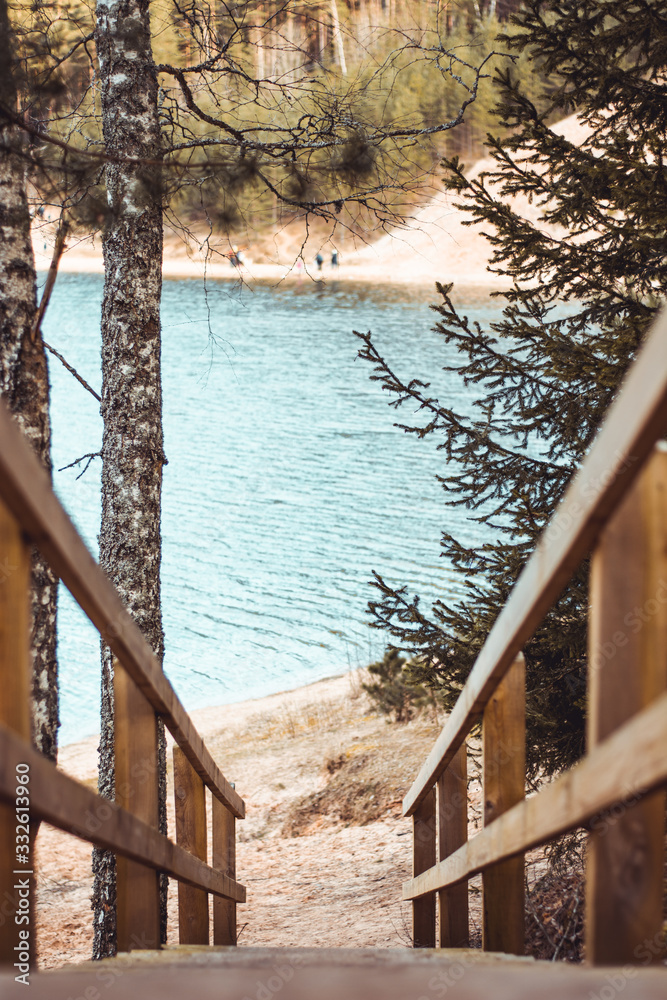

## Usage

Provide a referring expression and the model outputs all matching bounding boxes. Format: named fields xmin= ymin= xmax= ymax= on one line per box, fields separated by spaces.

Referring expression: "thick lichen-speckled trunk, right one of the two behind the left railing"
xmin=92 ymin=0 xmax=166 ymax=958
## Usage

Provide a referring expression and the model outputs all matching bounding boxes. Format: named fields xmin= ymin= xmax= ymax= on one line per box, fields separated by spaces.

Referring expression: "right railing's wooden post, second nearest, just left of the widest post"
xmin=482 ymin=655 xmax=526 ymax=955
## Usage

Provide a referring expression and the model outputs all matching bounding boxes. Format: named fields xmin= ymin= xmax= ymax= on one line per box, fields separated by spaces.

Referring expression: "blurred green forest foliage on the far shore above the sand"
xmin=7 ymin=0 xmax=544 ymax=237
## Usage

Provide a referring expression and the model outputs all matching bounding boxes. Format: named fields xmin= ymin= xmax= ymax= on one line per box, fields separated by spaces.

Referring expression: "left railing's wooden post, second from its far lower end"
xmin=173 ymin=747 xmax=209 ymax=944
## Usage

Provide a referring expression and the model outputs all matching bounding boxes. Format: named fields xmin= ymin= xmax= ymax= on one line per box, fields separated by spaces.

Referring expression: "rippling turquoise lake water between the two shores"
xmin=44 ymin=274 xmax=495 ymax=743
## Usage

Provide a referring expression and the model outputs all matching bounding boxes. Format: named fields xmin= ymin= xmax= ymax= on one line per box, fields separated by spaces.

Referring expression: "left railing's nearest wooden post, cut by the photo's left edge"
xmin=0 ymin=501 xmax=35 ymax=968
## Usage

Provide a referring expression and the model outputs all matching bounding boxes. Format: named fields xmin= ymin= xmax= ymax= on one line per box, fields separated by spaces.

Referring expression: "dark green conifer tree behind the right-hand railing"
xmin=360 ymin=0 xmax=667 ymax=777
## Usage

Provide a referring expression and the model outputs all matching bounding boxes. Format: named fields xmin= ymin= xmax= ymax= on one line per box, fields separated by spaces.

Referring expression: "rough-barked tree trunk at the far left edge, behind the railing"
xmin=0 ymin=0 xmax=58 ymax=760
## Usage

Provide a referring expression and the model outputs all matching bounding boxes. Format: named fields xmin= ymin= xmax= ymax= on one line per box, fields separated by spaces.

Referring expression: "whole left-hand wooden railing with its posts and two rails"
xmin=0 ymin=404 xmax=245 ymax=966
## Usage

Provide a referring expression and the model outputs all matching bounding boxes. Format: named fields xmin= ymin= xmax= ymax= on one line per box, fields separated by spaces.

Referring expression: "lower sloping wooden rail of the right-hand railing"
xmin=403 ymin=694 xmax=667 ymax=899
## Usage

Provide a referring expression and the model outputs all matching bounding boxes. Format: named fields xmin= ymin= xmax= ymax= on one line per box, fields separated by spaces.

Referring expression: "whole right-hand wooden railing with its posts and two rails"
xmin=403 ymin=312 xmax=667 ymax=965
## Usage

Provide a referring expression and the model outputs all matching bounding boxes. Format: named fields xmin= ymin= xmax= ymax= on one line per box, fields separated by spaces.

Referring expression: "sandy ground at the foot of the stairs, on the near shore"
xmin=36 ymin=672 xmax=468 ymax=967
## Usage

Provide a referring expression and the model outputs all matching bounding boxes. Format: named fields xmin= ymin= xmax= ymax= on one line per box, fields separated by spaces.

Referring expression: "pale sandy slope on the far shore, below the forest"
xmin=34 ymin=116 xmax=587 ymax=287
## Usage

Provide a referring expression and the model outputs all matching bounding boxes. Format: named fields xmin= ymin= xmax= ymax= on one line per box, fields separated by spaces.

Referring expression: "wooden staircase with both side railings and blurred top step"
xmin=0 ymin=314 xmax=667 ymax=1000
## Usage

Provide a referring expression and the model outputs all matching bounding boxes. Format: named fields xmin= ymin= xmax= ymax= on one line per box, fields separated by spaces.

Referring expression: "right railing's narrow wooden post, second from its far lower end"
xmin=437 ymin=742 xmax=469 ymax=948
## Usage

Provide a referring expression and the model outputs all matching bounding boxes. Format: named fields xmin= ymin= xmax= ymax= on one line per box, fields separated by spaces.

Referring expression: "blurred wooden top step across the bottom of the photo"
xmin=0 ymin=946 xmax=667 ymax=1000
